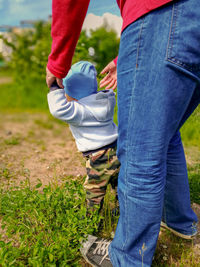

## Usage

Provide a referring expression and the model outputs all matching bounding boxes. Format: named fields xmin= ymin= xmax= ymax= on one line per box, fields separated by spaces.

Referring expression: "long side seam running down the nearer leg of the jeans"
xmin=122 ymin=19 xmax=144 ymax=254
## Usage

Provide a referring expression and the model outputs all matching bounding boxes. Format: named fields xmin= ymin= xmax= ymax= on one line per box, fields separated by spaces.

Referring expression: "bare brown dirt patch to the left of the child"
xmin=0 ymin=113 xmax=85 ymax=185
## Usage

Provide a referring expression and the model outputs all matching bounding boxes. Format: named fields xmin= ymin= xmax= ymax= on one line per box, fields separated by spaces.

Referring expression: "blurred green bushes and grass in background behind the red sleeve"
xmin=0 ymin=22 xmax=119 ymax=109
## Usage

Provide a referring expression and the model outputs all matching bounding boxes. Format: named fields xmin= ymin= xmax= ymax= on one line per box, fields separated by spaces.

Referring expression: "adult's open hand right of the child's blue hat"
xmin=100 ymin=61 xmax=117 ymax=90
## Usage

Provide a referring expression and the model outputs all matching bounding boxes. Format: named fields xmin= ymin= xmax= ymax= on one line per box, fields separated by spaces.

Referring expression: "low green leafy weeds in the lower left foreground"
xmin=0 ymin=180 xmax=99 ymax=267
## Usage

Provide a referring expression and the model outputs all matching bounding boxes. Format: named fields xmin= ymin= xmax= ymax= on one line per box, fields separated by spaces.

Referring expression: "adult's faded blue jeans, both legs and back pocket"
xmin=109 ymin=0 xmax=200 ymax=267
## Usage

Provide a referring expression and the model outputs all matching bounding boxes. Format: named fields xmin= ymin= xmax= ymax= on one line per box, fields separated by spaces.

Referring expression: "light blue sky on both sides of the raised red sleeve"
xmin=0 ymin=0 xmax=120 ymax=26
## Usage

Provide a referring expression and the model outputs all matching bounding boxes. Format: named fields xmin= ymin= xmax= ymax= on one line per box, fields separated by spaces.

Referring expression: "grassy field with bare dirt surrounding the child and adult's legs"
xmin=0 ymin=71 xmax=200 ymax=267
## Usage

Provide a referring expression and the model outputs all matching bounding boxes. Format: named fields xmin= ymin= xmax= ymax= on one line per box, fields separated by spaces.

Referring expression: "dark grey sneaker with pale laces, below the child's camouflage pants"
xmin=80 ymin=235 xmax=113 ymax=267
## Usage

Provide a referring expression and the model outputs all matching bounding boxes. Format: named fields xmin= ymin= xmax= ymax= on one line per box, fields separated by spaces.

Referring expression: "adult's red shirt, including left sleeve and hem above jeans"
xmin=47 ymin=0 xmax=173 ymax=78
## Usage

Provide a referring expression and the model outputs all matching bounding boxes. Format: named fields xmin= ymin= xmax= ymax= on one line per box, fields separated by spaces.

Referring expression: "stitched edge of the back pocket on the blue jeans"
xmin=166 ymin=3 xmax=200 ymax=71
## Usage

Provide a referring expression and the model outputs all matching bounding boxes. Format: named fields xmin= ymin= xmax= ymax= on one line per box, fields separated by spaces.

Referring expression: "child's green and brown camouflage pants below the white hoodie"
xmin=84 ymin=148 xmax=120 ymax=210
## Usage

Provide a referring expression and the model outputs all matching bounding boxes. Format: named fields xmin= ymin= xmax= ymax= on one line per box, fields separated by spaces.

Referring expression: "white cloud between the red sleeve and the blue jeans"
xmin=83 ymin=13 xmax=122 ymax=37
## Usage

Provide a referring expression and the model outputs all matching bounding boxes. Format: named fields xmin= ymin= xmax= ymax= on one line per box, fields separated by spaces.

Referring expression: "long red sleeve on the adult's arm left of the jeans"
xmin=47 ymin=0 xmax=90 ymax=78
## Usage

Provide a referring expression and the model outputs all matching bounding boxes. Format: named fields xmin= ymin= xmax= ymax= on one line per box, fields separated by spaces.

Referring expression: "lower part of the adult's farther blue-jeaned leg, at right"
xmin=162 ymin=131 xmax=198 ymax=236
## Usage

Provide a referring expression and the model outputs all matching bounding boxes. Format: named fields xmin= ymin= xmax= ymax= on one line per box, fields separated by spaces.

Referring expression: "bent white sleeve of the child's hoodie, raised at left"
xmin=47 ymin=89 xmax=84 ymax=125
